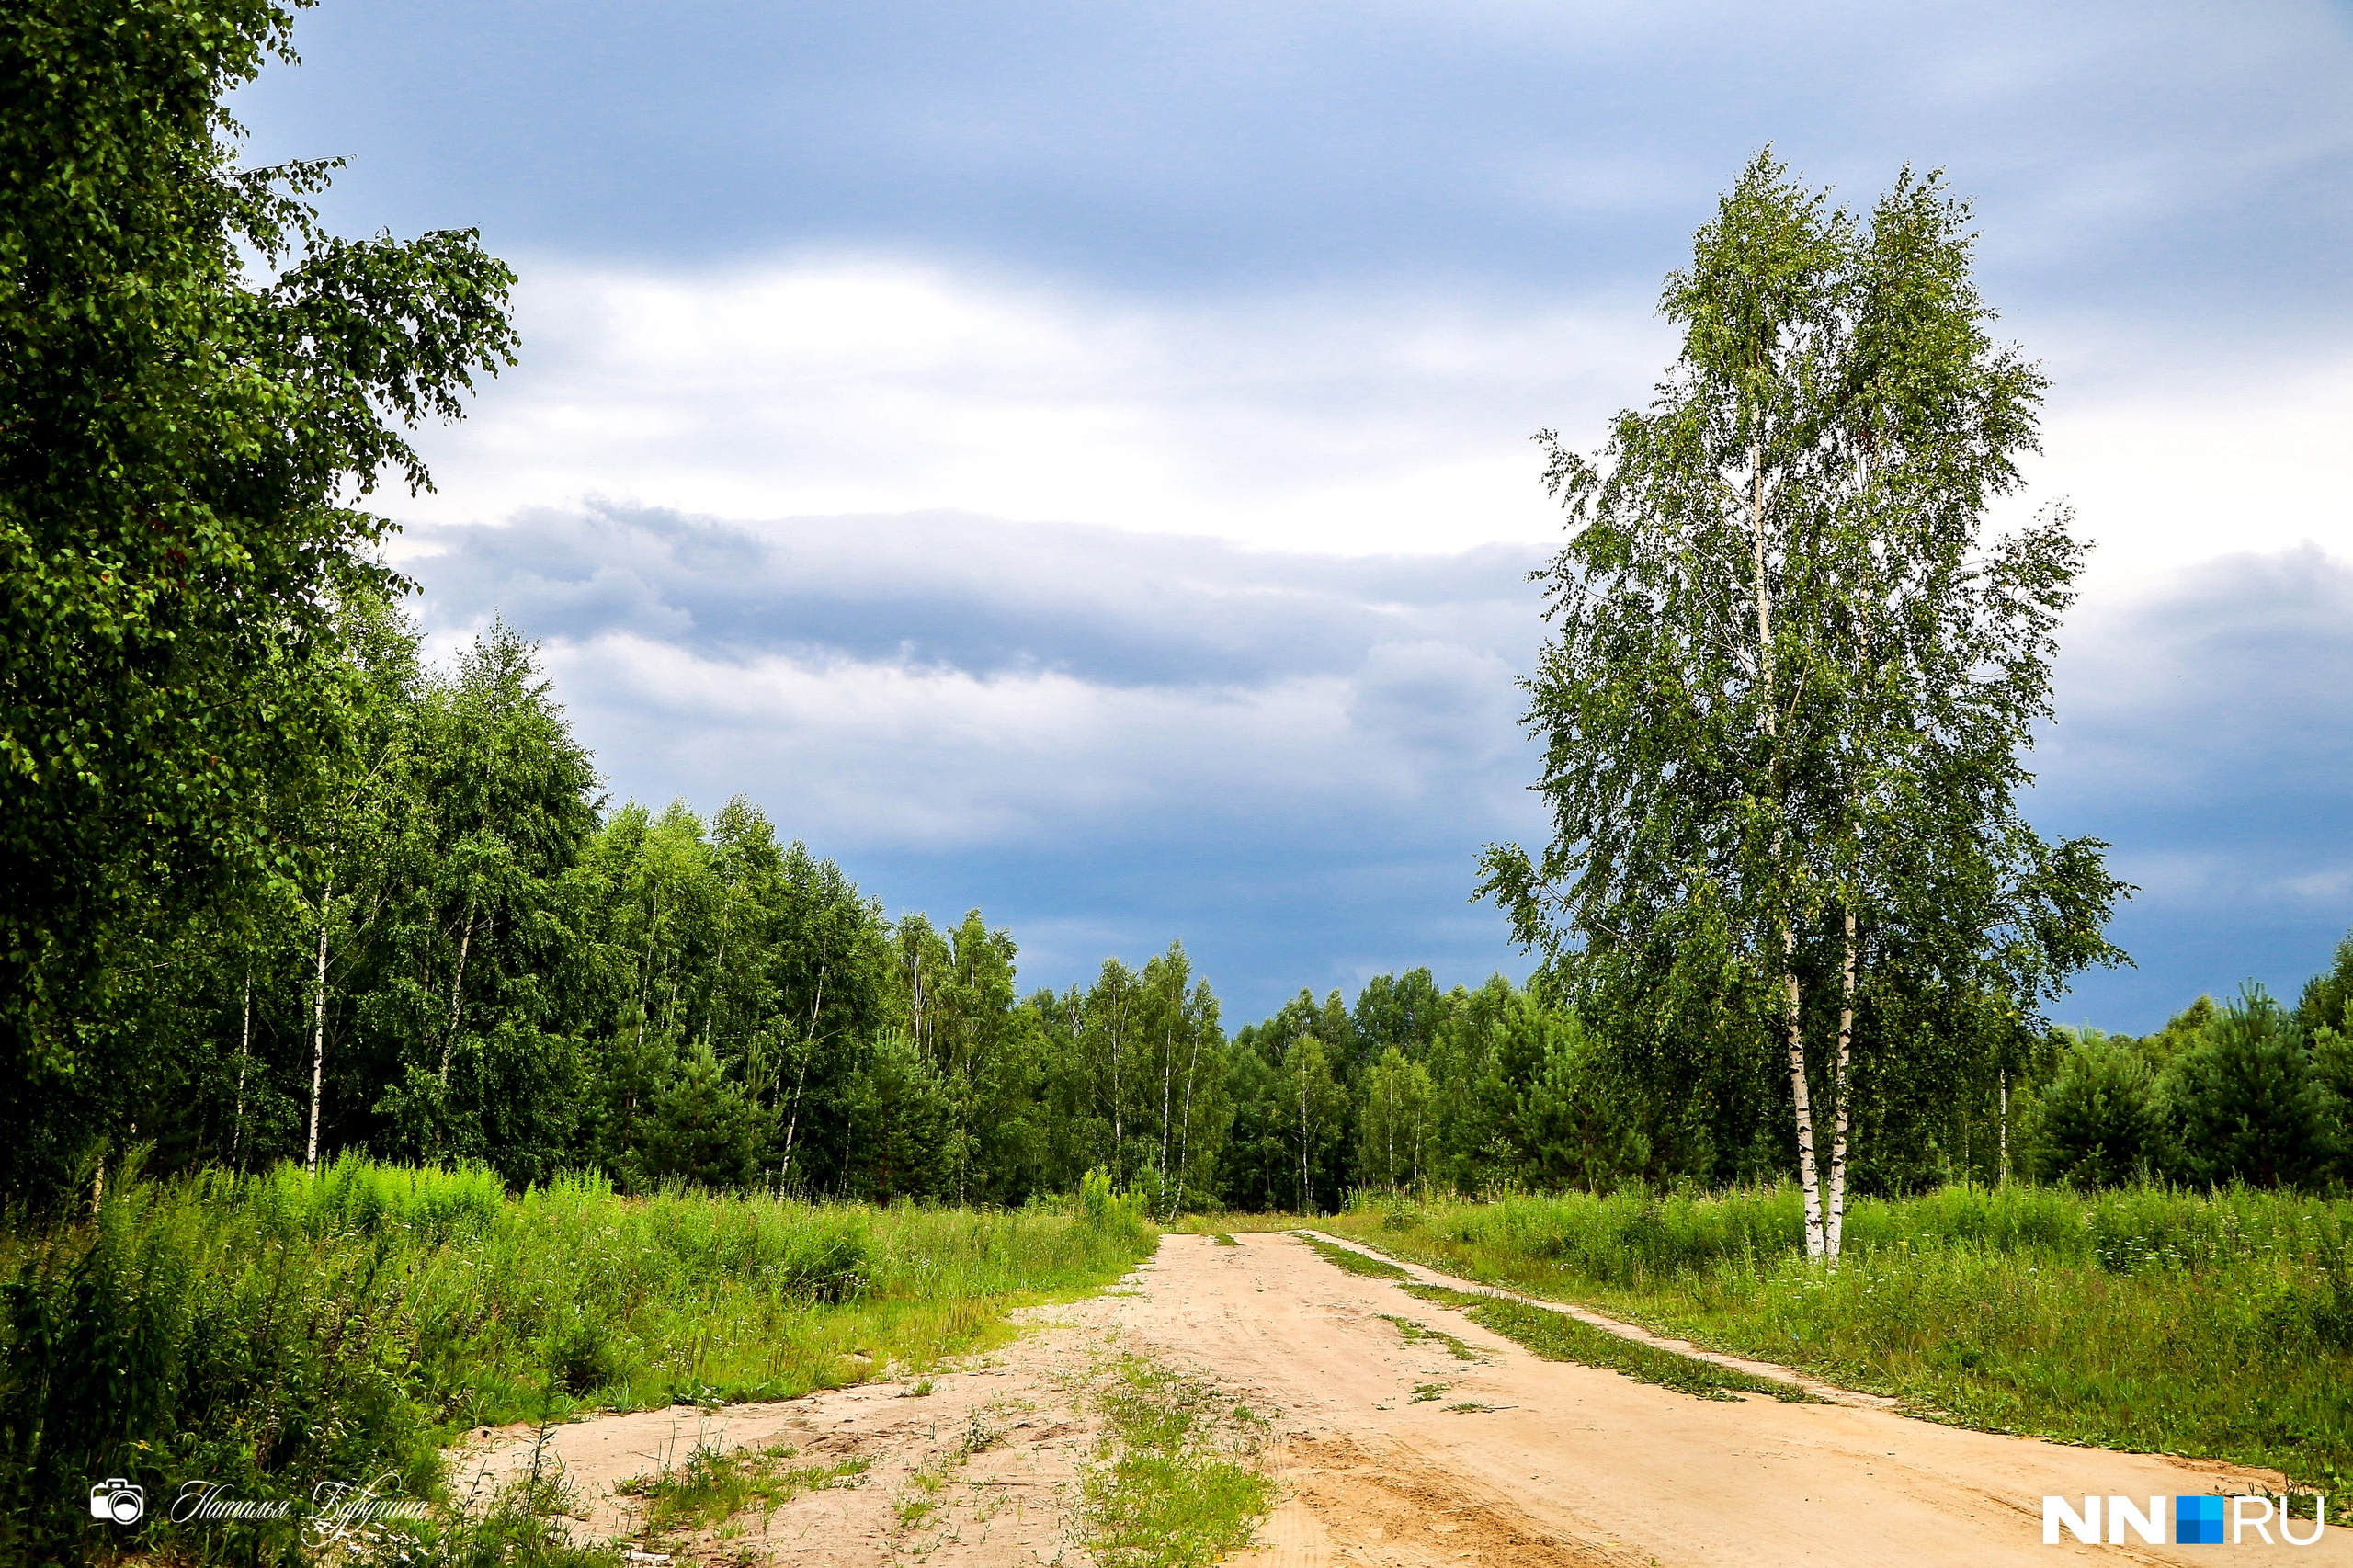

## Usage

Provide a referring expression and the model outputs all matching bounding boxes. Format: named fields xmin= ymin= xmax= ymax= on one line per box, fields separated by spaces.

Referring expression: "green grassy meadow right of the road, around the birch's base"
xmin=1324 ymin=1187 xmax=2353 ymax=1514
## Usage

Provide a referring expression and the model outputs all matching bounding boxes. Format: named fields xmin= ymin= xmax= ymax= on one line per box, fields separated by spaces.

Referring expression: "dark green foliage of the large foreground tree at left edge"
xmin=0 ymin=0 xmax=516 ymax=1182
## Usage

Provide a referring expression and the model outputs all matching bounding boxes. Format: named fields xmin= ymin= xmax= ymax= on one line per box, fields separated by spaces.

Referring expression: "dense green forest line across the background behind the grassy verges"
xmin=12 ymin=598 xmax=2353 ymax=1215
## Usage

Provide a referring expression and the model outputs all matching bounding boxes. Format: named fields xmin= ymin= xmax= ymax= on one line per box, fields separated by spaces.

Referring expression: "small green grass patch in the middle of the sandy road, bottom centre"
xmin=1083 ymin=1356 xmax=1268 ymax=1568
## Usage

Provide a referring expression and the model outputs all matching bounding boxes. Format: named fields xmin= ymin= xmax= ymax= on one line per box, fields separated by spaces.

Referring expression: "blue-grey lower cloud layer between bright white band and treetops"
xmin=409 ymin=506 xmax=2353 ymax=1028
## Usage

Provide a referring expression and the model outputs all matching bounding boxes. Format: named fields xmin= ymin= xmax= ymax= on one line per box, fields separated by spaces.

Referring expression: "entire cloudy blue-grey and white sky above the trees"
xmin=240 ymin=0 xmax=2353 ymax=1028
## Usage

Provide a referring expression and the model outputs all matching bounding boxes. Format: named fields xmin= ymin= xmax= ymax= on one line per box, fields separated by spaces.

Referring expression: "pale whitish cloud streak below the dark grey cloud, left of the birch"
xmin=543 ymin=633 xmax=1520 ymax=852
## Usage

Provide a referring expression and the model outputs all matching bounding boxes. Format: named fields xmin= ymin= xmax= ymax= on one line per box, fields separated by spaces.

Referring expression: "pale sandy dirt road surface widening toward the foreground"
xmin=449 ymin=1233 xmax=2353 ymax=1568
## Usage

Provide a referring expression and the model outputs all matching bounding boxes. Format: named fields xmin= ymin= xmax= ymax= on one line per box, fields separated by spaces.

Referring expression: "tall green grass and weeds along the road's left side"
xmin=0 ymin=1158 xmax=1155 ymax=1561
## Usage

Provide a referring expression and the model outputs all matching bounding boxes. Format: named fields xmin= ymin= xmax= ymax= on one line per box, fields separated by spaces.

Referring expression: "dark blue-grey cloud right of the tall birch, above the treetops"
xmin=2033 ymin=549 xmax=2353 ymax=1031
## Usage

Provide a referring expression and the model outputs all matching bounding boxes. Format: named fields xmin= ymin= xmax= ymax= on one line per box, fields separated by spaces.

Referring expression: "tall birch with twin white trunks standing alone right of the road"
xmin=1483 ymin=153 xmax=2122 ymax=1257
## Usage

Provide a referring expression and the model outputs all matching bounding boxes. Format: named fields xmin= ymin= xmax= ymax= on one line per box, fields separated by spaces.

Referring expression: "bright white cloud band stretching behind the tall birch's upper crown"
xmin=400 ymin=259 xmax=2353 ymax=582
